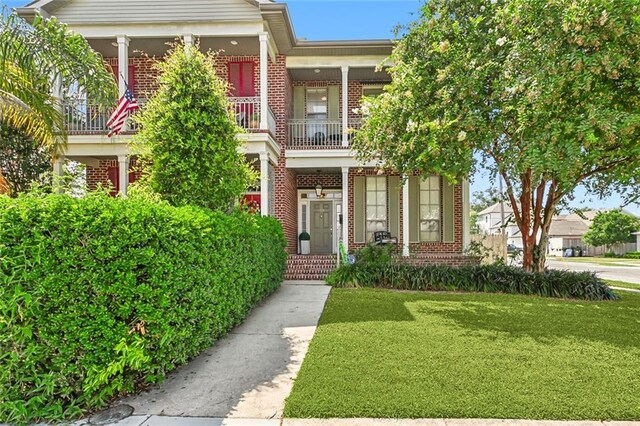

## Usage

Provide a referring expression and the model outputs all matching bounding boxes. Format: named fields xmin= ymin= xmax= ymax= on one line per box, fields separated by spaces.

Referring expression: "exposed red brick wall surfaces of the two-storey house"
xmin=87 ymin=55 xmax=469 ymax=265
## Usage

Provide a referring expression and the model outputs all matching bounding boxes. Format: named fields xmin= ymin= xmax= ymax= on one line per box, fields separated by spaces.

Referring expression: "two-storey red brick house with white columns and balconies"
xmin=18 ymin=0 xmax=469 ymax=278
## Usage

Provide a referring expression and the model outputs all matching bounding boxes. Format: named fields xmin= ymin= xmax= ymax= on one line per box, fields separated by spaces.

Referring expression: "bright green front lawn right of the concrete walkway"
xmin=285 ymin=289 xmax=640 ymax=420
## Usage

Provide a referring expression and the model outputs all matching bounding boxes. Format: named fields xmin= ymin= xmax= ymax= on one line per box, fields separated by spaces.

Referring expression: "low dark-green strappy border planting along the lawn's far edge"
xmin=327 ymin=247 xmax=616 ymax=300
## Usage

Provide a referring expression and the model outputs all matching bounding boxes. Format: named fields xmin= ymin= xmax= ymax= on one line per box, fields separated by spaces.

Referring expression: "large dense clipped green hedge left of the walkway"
xmin=0 ymin=195 xmax=286 ymax=423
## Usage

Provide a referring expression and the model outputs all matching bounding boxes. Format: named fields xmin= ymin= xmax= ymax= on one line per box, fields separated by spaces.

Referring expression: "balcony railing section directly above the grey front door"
xmin=287 ymin=119 xmax=342 ymax=148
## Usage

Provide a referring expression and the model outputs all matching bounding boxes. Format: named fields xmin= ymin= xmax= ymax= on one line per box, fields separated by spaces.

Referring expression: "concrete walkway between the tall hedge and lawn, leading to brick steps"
xmin=117 ymin=282 xmax=330 ymax=426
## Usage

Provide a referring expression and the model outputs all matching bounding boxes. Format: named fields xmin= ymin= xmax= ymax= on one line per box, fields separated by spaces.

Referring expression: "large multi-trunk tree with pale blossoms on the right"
xmin=355 ymin=0 xmax=640 ymax=270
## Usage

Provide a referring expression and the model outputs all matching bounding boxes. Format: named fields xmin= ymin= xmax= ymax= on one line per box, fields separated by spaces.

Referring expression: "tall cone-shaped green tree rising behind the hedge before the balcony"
xmin=136 ymin=45 xmax=257 ymax=210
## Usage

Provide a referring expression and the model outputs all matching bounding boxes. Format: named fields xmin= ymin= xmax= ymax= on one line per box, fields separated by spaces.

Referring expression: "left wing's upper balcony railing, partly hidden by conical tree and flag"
xmin=63 ymin=97 xmax=276 ymax=135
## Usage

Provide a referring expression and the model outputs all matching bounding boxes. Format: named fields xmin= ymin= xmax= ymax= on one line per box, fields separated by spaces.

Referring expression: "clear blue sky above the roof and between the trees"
xmin=0 ymin=0 xmax=640 ymax=215
